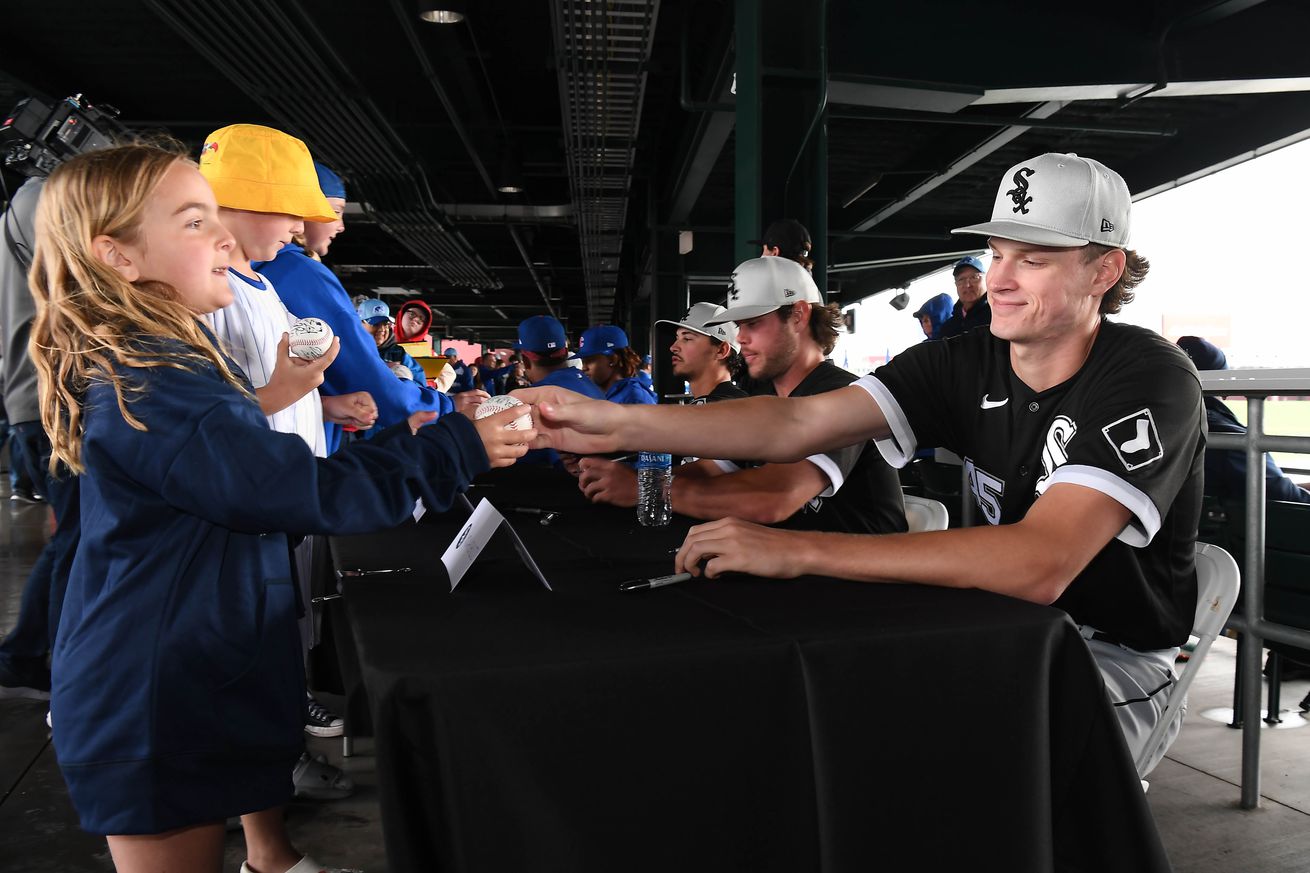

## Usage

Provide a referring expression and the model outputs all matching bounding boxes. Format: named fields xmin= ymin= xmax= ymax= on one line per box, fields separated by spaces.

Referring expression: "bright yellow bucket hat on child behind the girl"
xmin=200 ymin=125 xmax=337 ymax=222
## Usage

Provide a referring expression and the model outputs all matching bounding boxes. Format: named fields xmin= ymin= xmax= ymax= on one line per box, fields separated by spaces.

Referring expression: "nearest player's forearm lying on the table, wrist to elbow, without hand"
xmin=798 ymin=524 xmax=1086 ymax=604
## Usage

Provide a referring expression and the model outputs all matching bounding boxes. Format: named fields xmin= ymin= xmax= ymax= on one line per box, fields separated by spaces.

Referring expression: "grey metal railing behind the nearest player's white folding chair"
xmin=1200 ymin=368 xmax=1310 ymax=809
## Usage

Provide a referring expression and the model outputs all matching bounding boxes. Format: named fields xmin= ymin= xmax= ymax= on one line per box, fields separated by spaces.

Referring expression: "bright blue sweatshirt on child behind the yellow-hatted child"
xmin=257 ymin=243 xmax=455 ymax=454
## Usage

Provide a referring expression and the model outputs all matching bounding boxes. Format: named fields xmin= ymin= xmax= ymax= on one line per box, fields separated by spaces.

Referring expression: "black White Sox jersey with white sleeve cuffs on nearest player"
xmin=859 ymin=321 xmax=1205 ymax=649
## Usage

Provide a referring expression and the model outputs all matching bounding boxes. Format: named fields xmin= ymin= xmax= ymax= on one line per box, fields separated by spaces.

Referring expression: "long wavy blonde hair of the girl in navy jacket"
xmin=28 ymin=143 xmax=248 ymax=473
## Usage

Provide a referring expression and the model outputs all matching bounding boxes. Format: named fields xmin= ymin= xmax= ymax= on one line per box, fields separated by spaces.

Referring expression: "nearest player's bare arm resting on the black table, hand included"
xmin=676 ymin=484 xmax=1131 ymax=604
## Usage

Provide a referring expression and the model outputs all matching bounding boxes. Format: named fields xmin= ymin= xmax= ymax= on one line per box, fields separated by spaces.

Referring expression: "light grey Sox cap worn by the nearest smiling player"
xmin=951 ymin=152 xmax=1132 ymax=249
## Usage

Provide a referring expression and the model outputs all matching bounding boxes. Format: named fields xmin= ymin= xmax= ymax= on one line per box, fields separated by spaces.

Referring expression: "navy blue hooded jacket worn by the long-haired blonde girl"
xmin=51 ymin=341 xmax=487 ymax=834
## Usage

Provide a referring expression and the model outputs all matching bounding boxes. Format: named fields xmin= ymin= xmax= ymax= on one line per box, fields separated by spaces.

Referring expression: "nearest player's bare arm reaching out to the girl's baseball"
xmin=512 ymin=387 xmax=889 ymax=463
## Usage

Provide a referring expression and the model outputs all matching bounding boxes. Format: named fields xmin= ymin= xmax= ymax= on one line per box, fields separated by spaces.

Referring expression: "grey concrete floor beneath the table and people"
xmin=0 ymin=481 xmax=1310 ymax=873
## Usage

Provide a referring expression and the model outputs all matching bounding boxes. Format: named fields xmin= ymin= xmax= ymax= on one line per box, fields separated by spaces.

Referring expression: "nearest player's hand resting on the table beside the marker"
xmin=673 ymin=518 xmax=807 ymax=579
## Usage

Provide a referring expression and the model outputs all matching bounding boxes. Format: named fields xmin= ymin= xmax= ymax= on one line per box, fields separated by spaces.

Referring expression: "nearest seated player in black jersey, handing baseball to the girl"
xmin=523 ymin=153 xmax=1205 ymax=771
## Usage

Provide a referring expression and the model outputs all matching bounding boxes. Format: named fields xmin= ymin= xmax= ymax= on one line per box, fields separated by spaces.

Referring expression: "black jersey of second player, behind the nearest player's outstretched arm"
xmin=715 ymin=360 xmax=908 ymax=534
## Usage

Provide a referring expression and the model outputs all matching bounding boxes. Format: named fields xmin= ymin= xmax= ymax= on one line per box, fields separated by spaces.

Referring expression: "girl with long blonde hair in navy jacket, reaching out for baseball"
xmin=30 ymin=146 xmax=533 ymax=873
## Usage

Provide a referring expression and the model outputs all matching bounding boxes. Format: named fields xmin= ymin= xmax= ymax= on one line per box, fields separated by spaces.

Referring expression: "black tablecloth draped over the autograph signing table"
xmin=334 ymin=469 xmax=1169 ymax=873
